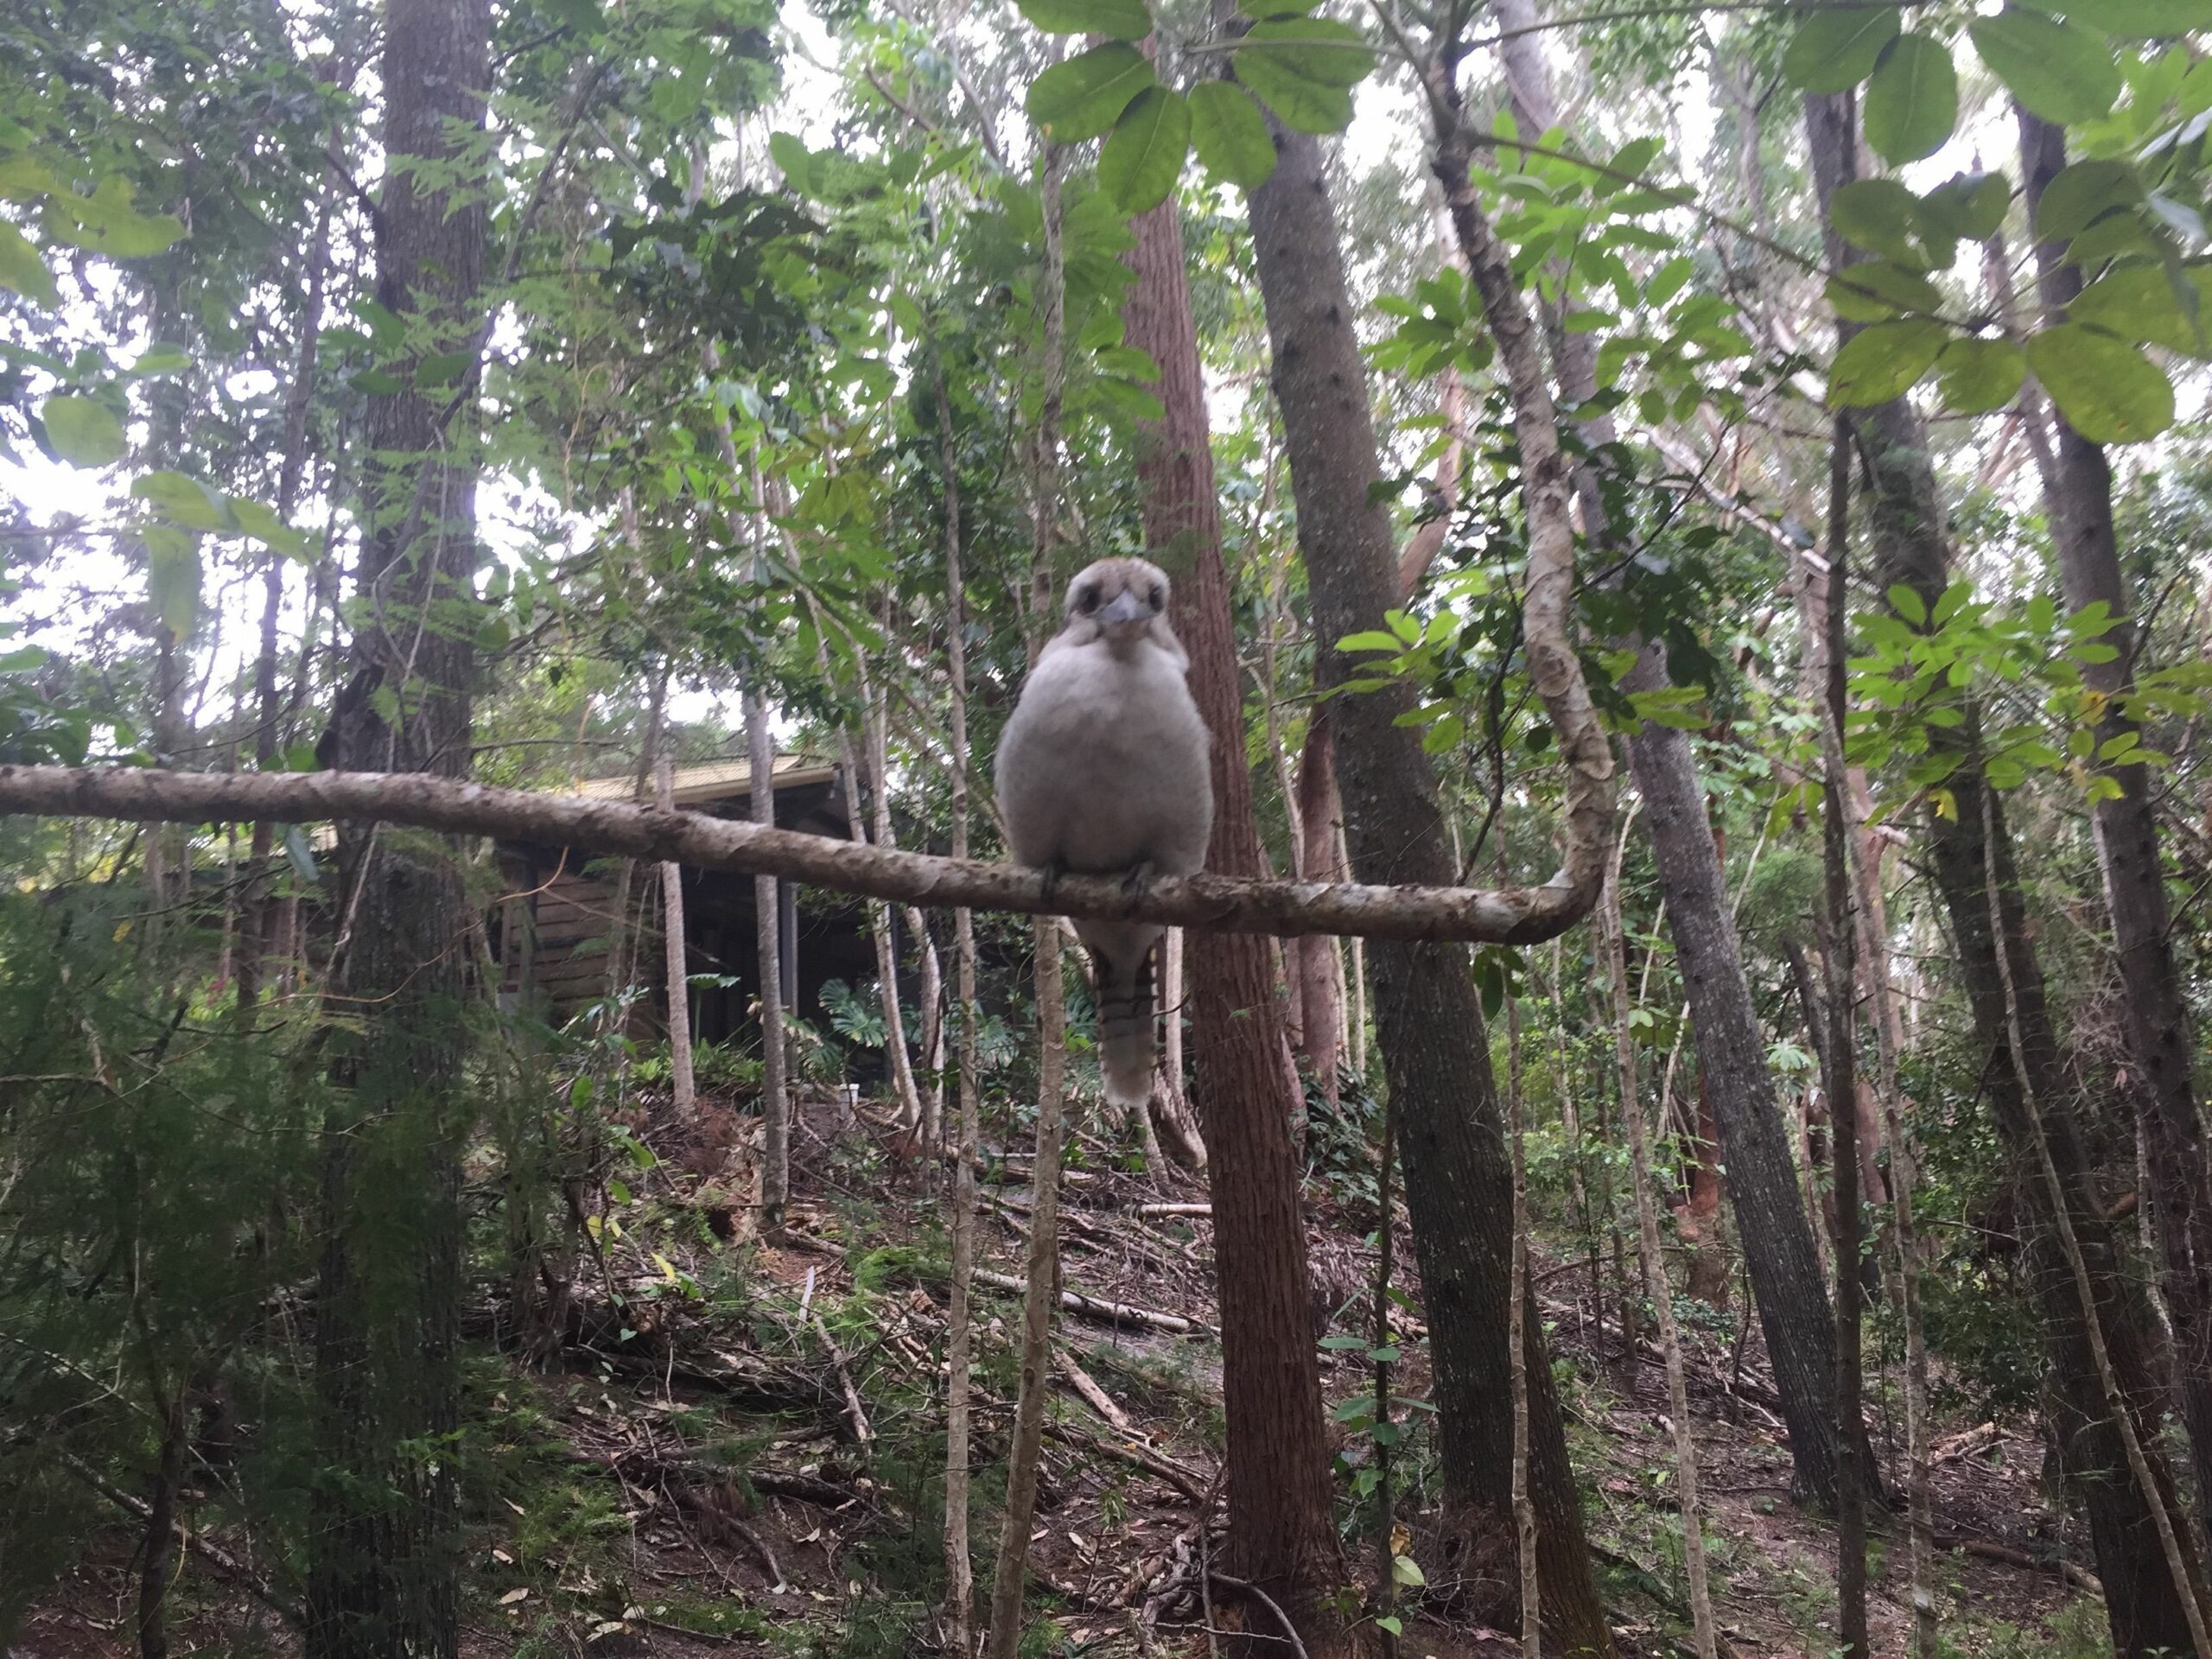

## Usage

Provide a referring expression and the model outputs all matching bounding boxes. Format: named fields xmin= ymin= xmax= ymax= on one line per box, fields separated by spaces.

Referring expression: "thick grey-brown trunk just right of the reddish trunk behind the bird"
xmin=1249 ymin=111 xmax=1615 ymax=1656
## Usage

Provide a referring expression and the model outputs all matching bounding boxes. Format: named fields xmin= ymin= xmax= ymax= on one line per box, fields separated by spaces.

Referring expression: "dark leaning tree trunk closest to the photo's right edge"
xmin=2019 ymin=111 xmax=2212 ymax=1517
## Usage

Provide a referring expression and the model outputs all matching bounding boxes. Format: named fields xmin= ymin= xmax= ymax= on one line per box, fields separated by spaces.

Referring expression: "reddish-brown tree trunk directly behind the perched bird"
xmin=1123 ymin=152 xmax=1344 ymax=1650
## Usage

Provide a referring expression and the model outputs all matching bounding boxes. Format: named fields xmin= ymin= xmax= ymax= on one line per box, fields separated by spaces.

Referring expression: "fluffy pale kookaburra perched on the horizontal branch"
xmin=998 ymin=560 xmax=1214 ymax=1109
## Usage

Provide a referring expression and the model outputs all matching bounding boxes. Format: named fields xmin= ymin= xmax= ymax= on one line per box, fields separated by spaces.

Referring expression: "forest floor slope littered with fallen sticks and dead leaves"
xmin=9 ymin=1102 xmax=2106 ymax=1659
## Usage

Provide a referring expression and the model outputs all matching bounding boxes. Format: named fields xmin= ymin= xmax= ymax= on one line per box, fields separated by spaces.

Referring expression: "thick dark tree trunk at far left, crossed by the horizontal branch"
xmin=305 ymin=0 xmax=491 ymax=1659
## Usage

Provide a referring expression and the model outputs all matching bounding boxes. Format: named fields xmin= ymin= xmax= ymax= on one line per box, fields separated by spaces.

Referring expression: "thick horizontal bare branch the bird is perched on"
xmin=0 ymin=766 xmax=1580 ymax=944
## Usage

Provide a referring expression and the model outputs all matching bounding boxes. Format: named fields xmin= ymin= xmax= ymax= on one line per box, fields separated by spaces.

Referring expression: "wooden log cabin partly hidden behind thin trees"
xmin=493 ymin=754 xmax=876 ymax=1042
